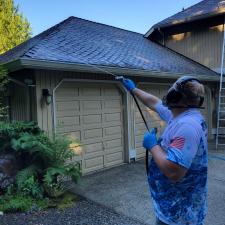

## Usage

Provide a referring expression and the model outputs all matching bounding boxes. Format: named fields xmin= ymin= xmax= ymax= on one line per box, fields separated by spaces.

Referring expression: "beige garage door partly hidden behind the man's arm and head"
xmin=135 ymin=84 xmax=210 ymax=159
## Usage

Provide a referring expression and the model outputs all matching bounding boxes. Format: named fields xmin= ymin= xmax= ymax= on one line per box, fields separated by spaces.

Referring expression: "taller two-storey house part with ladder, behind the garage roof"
xmin=145 ymin=0 xmax=225 ymax=137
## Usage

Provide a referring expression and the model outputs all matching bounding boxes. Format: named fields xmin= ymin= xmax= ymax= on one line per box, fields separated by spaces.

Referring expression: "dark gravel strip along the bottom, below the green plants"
xmin=0 ymin=199 xmax=146 ymax=225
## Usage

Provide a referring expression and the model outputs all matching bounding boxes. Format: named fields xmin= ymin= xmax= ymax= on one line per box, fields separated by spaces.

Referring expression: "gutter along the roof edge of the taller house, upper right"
xmin=144 ymin=10 xmax=225 ymax=38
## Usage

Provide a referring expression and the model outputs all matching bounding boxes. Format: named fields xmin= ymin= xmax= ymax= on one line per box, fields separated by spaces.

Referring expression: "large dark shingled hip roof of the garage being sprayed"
xmin=0 ymin=17 xmax=216 ymax=77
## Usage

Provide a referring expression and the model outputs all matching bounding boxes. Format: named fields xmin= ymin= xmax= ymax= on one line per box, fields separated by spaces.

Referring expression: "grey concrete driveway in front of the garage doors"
xmin=71 ymin=151 xmax=225 ymax=225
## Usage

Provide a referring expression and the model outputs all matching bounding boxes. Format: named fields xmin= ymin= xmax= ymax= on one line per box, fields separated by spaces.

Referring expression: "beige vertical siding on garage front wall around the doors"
xmin=35 ymin=70 xmax=215 ymax=162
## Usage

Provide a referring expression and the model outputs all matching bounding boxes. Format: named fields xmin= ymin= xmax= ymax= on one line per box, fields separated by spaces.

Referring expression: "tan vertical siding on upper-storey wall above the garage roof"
xmin=165 ymin=25 xmax=223 ymax=69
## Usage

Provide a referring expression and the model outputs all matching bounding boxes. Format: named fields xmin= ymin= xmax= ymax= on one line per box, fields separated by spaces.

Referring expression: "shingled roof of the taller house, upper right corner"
xmin=146 ymin=0 xmax=225 ymax=36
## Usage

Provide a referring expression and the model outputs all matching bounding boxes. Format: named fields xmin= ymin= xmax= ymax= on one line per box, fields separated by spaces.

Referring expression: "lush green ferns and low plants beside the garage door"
xmin=0 ymin=122 xmax=80 ymax=212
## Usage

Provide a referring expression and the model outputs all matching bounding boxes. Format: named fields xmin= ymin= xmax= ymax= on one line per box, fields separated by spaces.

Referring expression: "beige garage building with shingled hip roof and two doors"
xmin=0 ymin=4 xmax=219 ymax=174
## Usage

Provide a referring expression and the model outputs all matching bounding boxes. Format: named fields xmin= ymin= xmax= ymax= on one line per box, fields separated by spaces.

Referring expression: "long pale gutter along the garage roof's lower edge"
xmin=4 ymin=59 xmax=220 ymax=81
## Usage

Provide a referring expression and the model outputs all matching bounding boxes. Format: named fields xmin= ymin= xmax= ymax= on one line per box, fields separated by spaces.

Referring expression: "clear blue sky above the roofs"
xmin=14 ymin=0 xmax=200 ymax=35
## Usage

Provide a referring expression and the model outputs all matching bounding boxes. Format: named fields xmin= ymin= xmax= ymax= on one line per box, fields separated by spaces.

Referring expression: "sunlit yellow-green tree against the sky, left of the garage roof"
xmin=0 ymin=0 xmax=31 ymax=54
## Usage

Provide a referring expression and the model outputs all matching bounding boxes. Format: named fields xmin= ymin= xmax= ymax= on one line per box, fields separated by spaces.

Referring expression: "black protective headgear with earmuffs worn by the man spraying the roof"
xmin=163 ymin=76 xmax=204 ymax=108
